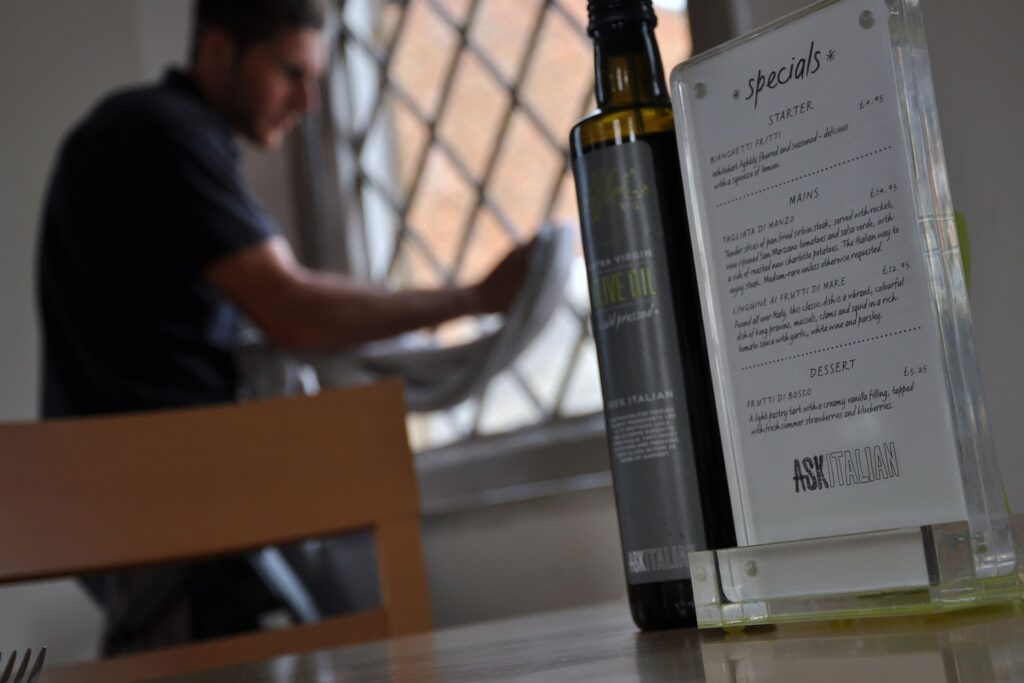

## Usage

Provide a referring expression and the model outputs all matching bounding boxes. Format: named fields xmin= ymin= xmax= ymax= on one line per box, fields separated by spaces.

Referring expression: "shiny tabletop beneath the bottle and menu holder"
xmin=153 ymin=603 xmax=1024 ymax=683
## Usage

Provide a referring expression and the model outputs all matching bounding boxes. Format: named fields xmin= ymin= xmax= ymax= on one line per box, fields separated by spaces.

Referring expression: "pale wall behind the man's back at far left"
xmin=0 ymin=0 xmax=148 ymax=661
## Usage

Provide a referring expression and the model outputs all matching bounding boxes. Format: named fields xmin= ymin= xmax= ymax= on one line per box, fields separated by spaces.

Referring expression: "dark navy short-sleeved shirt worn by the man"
xmin=38 ymin=72 xmax=278 ymax=417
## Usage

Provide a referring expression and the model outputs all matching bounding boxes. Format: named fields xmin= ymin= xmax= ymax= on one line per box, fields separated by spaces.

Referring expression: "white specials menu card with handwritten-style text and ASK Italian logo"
xmin=673 ymin=0 xmax=968 ymax=546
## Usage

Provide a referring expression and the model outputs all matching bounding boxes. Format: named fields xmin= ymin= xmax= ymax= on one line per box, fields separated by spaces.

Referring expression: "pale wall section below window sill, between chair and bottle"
xmin=423 ymin=487 xmax=626 ymax=627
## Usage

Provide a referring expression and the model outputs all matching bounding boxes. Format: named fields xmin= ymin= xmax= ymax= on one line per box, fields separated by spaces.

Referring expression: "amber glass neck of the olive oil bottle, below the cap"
xmin=593 ymin=20 xmax=669 ymax=110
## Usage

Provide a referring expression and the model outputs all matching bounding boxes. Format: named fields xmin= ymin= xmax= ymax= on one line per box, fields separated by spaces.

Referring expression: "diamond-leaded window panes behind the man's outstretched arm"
xmin=319 ymin=0 xmax=690 ymax=450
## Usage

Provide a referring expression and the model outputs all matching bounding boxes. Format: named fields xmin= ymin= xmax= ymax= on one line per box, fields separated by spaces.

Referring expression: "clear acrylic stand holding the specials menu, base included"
xmin=672 ymin=0 xmax=1024 ymax=627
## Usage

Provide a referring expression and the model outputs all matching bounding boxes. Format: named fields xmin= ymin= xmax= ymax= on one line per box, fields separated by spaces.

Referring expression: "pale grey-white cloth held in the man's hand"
xmin=239 ymin=226 xmax=575 ymax=411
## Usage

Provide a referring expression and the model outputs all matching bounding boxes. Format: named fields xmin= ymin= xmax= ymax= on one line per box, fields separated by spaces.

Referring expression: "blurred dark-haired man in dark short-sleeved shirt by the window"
xmin=38 ymin=0 xmax=526 ymax=651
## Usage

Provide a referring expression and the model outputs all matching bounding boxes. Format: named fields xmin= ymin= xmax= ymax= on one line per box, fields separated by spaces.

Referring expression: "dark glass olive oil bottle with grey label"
xmin=570 ymin=0 xmax=735 ymax=630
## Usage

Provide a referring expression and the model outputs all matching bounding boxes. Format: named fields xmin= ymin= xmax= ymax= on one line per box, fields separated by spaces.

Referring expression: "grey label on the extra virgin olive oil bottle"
xmin=573 ymin=141 xmax=705 ymax=584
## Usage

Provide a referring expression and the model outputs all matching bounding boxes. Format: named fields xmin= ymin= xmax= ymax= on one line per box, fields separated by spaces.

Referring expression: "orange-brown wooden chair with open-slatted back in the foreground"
xmin=0 ymin=383 xmax=430 ymax=683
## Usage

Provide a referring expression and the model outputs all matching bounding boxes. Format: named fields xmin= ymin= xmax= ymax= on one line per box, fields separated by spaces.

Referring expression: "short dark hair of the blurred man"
xmin=193 ymin=0 xmax=324 ymax=59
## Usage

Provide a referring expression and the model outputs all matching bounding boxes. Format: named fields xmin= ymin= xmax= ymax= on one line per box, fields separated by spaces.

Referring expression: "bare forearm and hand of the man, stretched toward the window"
xmin=206 ymin=237 xmax=528 ymax=350
